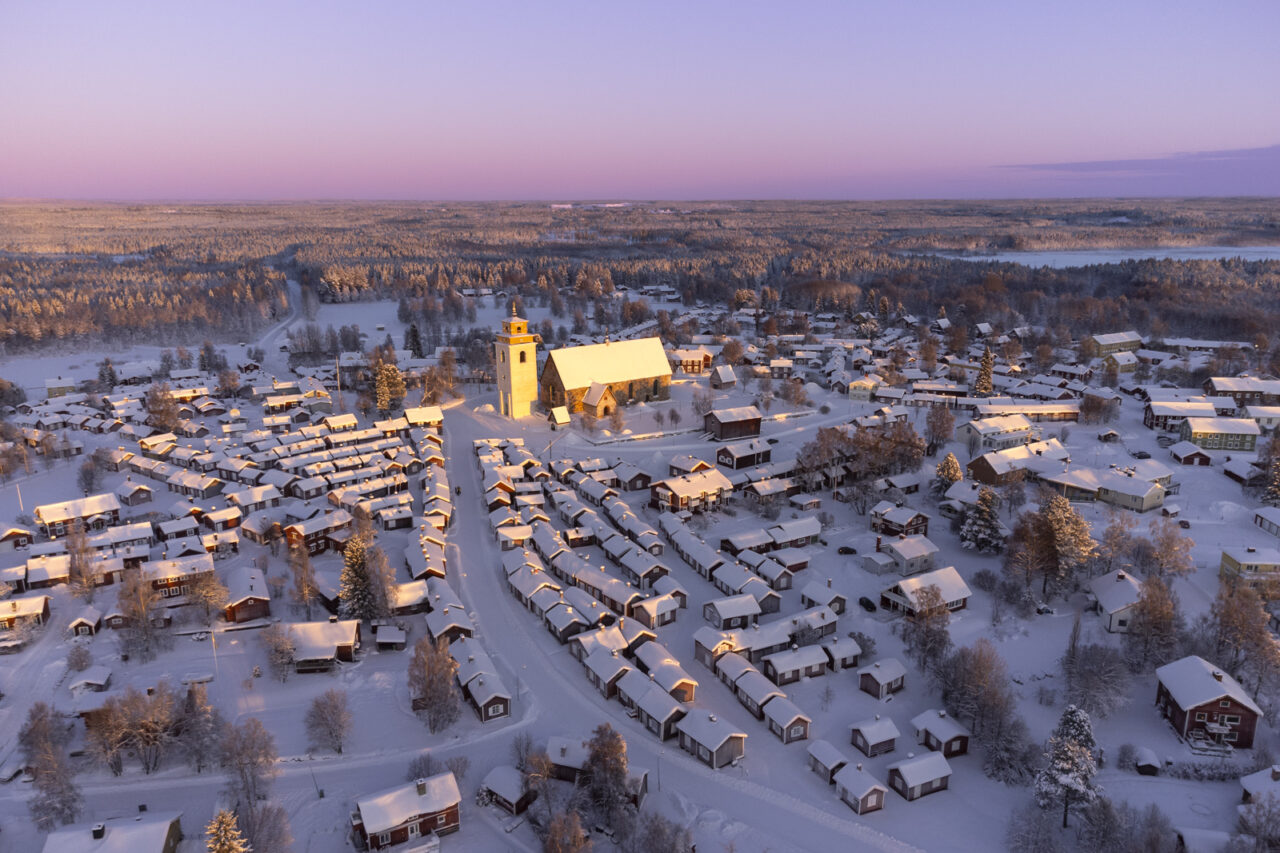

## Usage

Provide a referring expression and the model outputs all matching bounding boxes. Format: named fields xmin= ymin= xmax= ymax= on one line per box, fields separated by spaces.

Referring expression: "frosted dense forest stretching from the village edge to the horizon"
xmin=0 ymin=199 xmax=1280 ymax=350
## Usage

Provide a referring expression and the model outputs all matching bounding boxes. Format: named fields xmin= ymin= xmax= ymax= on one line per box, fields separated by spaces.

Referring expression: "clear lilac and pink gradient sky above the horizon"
xmin=0 ymin=0 xmax=1280 ymax=200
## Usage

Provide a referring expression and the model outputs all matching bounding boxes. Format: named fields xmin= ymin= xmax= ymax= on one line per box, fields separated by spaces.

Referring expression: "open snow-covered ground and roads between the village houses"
xmin=0 ymin=302 xmax=1275 ymax=853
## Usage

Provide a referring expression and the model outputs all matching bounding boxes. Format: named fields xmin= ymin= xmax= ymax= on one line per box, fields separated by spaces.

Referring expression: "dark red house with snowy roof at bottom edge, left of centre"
xmin=351 ymin=772 xmax=462 ymax=850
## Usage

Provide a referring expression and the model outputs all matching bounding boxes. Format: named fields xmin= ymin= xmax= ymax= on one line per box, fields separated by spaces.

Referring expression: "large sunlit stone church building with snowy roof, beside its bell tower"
xmin=538 ymin=337 xmax=671 ymax=415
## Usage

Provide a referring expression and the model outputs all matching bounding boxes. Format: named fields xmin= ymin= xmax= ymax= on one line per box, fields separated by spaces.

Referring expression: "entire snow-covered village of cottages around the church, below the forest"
xmin=0 ymin=253 xmax=1280 ymax=853
